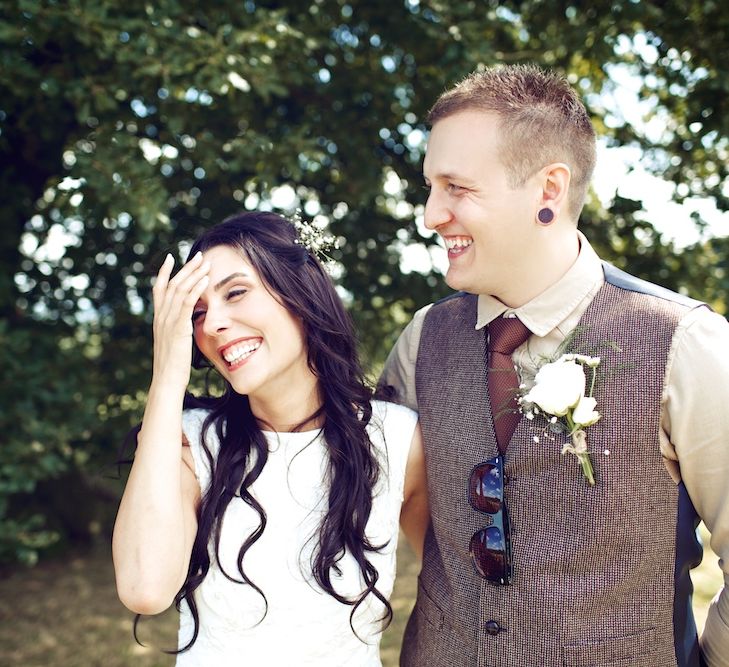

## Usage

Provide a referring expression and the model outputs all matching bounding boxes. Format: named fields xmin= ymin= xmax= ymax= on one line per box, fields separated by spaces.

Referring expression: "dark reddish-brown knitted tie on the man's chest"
xmin=488 ymin=317 xmax=531 ymax=454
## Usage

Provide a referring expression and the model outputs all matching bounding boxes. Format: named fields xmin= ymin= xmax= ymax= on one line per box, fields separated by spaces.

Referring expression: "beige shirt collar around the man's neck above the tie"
xmin=476 ymin=231 xmax=604 ymax=336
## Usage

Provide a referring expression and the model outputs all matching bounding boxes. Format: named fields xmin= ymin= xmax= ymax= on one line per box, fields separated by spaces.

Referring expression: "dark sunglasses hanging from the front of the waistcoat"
xmin=468 ymin=456 xmax=511 ymax=584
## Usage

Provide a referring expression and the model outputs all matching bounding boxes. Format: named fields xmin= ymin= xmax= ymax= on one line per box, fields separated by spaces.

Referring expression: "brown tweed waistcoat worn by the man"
xmin=401 ymin=268 xmax=695 ymax=667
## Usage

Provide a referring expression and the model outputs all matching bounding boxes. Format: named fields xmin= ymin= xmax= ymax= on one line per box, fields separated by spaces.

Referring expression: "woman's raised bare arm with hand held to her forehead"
xmin=112 ymin=256 xmax=209 ymax=614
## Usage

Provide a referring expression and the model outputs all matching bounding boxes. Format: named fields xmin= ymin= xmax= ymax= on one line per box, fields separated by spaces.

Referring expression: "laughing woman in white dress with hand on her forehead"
xmin=113 ymin=212 xmax=428 ymax=667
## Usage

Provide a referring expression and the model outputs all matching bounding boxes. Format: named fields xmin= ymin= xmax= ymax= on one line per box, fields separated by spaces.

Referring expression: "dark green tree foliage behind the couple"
xmin=0 ymin=0 xmax=729 ymax=560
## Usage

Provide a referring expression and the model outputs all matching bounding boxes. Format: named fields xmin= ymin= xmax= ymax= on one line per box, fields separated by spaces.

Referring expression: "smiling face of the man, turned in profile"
xmin=423 ymin=110 xmax=541 ymax=306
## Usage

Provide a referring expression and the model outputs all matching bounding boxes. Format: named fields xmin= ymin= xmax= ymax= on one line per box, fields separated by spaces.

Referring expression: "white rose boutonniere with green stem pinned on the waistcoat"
xmin=519 ymin=354 xmax=600 ymax=486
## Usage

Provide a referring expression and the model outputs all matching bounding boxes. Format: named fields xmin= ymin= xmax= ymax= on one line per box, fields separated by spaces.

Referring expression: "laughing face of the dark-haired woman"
xmin=192 ymin=246 xmax=315 ymax=401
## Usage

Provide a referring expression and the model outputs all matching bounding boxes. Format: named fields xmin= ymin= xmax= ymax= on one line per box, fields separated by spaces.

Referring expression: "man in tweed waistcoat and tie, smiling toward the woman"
xmin=381 ymin=66 xmax=729 ymax=667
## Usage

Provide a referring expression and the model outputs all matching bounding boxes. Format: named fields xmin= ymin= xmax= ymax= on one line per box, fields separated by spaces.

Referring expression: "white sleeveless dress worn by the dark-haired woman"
xmin=176 ymin=401 xmax=417 ymax=667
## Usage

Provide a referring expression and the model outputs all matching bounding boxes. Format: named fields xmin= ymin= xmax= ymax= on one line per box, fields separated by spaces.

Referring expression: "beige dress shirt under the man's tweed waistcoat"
xmin=381 ymin=232 xmax=729 ymax=667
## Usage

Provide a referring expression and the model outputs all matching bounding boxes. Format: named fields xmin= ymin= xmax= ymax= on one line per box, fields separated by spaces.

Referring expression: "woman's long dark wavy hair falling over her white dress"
xmin=175 ymin=212 xmax=392 ymax=650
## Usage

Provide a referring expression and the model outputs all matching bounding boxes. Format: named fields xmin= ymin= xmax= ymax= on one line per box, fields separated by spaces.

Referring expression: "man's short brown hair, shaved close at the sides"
xmin=428 ymin=65 xmax=596 ymax=220
